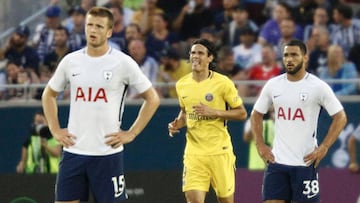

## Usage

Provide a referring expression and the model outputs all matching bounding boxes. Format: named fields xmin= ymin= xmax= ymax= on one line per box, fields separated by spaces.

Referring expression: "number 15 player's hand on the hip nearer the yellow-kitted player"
xmin=105 ymin=131 xmax=136 ymax=149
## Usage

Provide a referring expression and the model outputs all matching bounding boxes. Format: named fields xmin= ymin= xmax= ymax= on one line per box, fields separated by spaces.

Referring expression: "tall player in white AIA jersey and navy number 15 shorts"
xmin=42 ymin=7 xmax=160 ymax=203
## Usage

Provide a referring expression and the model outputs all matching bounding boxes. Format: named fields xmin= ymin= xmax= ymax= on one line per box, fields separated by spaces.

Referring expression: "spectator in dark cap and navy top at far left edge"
xmin=0 ymin=26 xmax=40 ymax=74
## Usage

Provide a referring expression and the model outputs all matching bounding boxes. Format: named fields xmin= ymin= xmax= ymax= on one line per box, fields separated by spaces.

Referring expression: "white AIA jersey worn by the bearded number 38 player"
xmin=254 ymin=73 xmax=343 ymax=166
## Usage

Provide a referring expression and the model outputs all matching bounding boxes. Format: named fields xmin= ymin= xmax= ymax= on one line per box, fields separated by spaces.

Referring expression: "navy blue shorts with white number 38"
xmin=262 ymin=163 xmax=320 ymax=202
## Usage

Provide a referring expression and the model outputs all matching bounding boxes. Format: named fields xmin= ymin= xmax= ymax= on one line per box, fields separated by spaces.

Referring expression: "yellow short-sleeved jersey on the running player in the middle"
xmin=176 ymin=71 xmax=242 ymax=155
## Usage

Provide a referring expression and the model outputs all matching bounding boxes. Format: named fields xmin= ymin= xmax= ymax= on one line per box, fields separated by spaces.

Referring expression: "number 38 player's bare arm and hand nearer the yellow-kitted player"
xmin=250 ymin=109 xmax=275 ymax=163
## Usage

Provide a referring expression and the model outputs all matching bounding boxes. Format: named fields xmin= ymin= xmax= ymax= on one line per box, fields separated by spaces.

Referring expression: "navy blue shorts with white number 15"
xmin=55 ymin=152 xmax=127 ymax=203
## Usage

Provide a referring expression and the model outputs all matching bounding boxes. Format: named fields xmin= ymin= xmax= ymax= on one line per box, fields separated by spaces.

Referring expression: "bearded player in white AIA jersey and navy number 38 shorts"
xmin=251 ymin=40 xmax=347 ymax=203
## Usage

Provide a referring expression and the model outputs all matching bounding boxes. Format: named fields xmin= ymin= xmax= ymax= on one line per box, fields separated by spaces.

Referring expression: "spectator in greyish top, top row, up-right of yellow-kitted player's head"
xmin=222 ymin=5 xmax=259 ymax=46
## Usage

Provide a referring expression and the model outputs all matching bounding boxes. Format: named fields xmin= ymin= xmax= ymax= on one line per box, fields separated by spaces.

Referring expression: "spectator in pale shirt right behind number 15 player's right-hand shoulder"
xmin=128 ymin=39 xmax=159 ymax=98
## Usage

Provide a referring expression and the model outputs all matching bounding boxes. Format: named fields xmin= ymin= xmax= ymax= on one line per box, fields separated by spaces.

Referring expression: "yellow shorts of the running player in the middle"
xmin=182 ymin=153 xmax=236 ymax=197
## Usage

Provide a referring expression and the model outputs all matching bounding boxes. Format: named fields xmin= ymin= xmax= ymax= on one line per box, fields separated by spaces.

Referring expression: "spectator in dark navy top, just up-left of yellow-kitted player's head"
xmin=145 ymin=13 xmax=179 ymax=62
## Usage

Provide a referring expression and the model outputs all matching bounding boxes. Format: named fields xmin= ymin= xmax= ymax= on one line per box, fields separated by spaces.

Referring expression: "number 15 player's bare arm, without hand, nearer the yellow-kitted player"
xmin=129 ymin=87 xmax=160 ymax=139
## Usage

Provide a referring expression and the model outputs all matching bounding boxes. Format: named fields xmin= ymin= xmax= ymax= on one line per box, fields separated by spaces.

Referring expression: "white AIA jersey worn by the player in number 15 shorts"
xmin=48 ymin=48 xmax=152 ymax=155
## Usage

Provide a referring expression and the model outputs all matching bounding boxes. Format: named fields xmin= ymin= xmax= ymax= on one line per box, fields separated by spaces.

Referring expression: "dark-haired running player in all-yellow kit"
xmin=168 ymin=39 xmax=247 ymax=203
